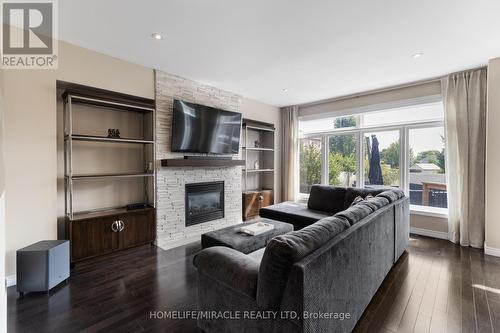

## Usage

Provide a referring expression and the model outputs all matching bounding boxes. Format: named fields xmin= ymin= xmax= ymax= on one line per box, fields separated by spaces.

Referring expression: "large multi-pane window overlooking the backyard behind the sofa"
xmin=299 ymin=101 xmax=447 ymax=213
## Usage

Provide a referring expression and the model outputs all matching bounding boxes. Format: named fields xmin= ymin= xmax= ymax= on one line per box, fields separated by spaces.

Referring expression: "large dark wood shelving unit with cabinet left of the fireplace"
xmin=61 ymin=81 xmax=156 ymax=263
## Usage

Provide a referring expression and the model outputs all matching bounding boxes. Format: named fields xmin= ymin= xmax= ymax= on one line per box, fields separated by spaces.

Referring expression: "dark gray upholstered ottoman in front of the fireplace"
xmin=201 ymin=218 xmax=293 ymax=254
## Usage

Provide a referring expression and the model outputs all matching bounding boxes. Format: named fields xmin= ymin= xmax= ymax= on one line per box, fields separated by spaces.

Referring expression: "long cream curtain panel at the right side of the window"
xmin=442 ymin=69 xmax=487 ymax=248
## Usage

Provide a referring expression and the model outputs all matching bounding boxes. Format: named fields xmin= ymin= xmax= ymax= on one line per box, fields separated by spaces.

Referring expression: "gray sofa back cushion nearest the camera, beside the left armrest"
xmin=257 ymin=216 xmax=349 ymax=309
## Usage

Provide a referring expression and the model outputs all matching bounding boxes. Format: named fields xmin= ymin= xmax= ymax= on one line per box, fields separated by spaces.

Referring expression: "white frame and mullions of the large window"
xmin=295 ymin=100 xmax=448 ymax=217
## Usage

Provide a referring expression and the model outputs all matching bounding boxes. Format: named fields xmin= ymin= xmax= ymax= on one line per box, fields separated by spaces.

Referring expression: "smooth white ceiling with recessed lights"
xmin=59 ymin=0 xmax=500 ymax=106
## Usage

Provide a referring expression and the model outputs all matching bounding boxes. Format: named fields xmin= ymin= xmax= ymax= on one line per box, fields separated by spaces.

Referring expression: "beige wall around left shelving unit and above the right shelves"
xmin=2 ymin=42 xmax=279 ymax=275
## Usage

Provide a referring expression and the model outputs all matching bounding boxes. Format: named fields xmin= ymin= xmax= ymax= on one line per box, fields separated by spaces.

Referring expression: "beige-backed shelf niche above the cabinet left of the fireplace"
xmin=62 ymin=83 xmax=155 ymax=219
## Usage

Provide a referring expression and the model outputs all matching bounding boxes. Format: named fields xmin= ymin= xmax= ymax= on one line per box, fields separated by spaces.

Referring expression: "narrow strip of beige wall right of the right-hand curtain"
xmin=485 ymin=58 xmax=500 ymax=251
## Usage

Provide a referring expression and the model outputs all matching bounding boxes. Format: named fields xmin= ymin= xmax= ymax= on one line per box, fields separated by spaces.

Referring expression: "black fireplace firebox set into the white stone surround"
xmin=185 ymin=181 xmax=224 ymax=227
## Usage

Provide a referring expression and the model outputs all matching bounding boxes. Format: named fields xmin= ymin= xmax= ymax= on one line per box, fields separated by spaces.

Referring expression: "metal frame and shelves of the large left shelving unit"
xmin=63 ymin=93 xmax=156 ymax=220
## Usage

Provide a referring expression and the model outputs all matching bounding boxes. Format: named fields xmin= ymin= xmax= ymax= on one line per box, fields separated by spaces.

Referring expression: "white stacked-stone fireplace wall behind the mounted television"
xmin=155 ymin=71 xmax=242 ymax=249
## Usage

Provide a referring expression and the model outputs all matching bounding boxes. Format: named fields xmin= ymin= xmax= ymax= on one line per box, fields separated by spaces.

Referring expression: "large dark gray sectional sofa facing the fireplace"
xmin=194 ymin=186 xmax=409 ymax=333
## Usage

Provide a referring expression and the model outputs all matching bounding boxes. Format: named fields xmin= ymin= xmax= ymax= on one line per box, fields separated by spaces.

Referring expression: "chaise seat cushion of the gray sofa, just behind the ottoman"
xmin=259 ymin=201 xmax=331 ymax=230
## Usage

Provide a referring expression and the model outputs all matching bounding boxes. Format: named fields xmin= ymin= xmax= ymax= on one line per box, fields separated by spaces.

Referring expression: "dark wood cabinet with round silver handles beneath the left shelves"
xmin=67 ymin=208 xmax=156 ymax=262
